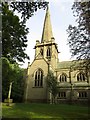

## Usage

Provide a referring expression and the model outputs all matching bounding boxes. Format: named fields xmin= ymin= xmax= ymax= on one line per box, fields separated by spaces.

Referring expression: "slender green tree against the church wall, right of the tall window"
xmin=45 ymin=71 xmax=58 ymax=103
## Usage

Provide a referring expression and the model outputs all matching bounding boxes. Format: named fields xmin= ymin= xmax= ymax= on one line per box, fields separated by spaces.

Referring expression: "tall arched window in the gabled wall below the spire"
xmin=35 ymin=69 xmax=43 ymax=87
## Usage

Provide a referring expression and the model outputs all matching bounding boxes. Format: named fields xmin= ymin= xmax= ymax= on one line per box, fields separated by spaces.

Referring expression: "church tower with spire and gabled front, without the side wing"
xmin=25 ymin=7 xmax=58 ymax=102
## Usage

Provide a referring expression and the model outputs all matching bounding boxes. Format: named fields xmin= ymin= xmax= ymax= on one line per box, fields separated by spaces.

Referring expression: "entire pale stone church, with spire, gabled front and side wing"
xmin=25 ymin=8 xmax=90 ymax=103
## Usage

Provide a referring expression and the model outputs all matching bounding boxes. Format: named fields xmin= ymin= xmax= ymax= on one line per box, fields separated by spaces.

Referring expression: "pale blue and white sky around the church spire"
xmin=22 ymin=0 xmax=76 ymax=68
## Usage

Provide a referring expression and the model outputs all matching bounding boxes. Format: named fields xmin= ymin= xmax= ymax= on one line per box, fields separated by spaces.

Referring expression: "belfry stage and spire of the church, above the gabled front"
xmin=35 ymin=7 xmax=59 ymax=70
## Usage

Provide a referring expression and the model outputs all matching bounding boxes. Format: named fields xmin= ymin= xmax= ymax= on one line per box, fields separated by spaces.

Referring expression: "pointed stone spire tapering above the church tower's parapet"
xmin=41 ymin=6 xmax=53 ymax=42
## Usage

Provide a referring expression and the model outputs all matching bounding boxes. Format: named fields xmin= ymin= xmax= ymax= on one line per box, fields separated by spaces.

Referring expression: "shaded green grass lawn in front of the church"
xmin=2 ymin=103 xmax=88 ymax=120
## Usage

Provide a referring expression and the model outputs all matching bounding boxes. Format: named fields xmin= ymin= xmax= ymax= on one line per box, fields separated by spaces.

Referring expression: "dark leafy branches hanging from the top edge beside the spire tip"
xmin=10 ymin=0 xmax=48 ymax=22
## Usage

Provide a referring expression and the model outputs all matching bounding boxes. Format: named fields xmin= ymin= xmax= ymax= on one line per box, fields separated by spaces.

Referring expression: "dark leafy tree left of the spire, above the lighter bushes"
xmin=2 ymin=4 xmax=29 ymax=62
